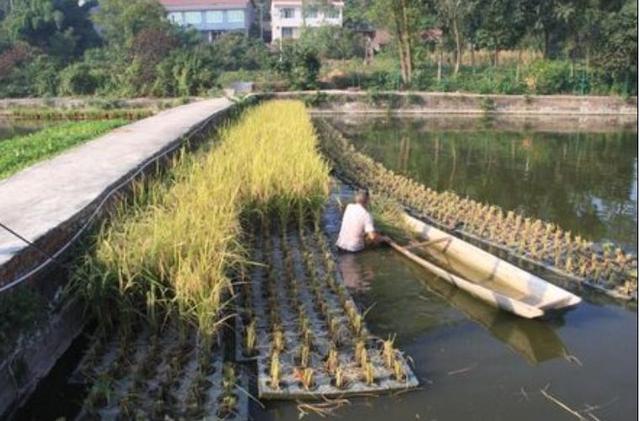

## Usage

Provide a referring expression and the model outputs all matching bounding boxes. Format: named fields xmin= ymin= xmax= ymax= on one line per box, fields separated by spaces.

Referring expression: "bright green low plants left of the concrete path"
xmin=0 ymin=119 xmax=127 ymax=179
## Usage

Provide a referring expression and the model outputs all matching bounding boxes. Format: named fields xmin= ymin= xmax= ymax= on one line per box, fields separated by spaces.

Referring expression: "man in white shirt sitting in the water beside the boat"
xmin=336 ymin=190 xmax=389 ymax=253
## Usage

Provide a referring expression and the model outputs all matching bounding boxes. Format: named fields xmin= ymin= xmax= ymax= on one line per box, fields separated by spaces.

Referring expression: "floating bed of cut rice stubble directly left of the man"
xmin=238 ymin=215 xmax=418 ymax=399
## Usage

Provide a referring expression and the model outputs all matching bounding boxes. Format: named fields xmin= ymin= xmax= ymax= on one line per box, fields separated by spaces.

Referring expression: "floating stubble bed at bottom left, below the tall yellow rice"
xmin=72 ymin=327 xmax=248 ymax=420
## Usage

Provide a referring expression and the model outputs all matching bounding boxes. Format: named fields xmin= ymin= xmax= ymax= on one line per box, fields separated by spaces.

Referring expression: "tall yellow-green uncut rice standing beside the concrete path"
xmin=75 ymin=101 xmax=329 ymax=341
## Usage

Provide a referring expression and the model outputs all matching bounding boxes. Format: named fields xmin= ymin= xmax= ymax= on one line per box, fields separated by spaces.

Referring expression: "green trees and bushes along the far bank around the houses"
xmin=0 ymin=0 xmax=638 ymax=97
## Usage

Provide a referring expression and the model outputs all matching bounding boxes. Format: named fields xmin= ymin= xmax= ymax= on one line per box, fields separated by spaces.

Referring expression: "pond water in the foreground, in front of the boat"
xmin=256 ymin=184 xmax=638 ymax=421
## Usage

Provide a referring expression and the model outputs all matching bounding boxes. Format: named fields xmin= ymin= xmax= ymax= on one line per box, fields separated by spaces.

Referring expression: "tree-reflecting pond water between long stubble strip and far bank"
xmin=322 ymin=117 xmax=638 ymax=251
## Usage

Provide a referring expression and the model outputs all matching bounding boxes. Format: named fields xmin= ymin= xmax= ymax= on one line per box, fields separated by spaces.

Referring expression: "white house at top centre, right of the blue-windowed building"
xmin=271 ymin=0 xmax=344 ymax=41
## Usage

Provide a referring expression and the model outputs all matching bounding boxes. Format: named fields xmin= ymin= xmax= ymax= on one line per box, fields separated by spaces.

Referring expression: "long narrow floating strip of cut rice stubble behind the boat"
xmin=316 ymin=120 xmax=638 ymax=300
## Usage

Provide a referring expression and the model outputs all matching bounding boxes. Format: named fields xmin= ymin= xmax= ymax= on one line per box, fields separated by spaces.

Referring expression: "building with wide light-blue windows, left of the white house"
xmin=160 ymin=0 xmax=255 ymax=41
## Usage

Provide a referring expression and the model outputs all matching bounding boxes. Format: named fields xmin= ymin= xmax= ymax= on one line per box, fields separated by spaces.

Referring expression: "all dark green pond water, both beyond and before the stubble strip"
xmin=256 ymin=118 xmax=638 ymax=421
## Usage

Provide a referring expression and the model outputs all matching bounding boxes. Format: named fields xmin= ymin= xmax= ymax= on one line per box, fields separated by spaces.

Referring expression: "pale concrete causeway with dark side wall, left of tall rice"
xmin=0 ymin=99 xmax=232 ymax=418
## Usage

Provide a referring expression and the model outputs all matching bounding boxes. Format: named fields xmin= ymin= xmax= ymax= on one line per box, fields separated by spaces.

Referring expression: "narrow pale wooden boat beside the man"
xmin=390 ymin=214 xmax=582 ymax=319
